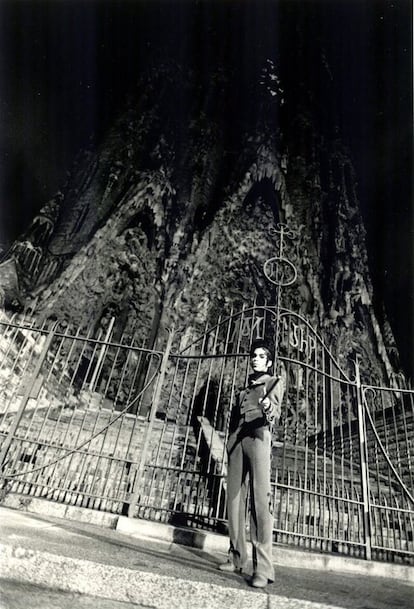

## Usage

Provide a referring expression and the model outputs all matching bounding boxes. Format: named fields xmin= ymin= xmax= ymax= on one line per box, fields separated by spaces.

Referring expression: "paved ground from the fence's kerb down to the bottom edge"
xmin=0 ymin=508 xmax=414 ymax=609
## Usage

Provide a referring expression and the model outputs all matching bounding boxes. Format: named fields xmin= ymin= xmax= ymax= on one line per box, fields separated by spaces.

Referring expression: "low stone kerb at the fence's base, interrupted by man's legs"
xmin=2 ymin=493 xmax=414 ymax=584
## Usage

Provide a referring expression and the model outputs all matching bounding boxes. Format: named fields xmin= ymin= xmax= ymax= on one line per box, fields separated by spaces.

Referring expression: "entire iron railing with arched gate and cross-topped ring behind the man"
xmin=0 ymin=228 xmax=414 ymax=562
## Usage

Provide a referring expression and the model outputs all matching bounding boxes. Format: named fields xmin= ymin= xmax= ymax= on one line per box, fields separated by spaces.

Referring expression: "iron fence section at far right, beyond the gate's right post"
xmin=362 ymin=386 xmax=414 ymax=560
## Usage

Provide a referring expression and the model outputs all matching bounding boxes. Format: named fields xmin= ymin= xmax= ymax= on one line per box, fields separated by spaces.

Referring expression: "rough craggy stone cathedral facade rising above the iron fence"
xmin=0 ymin=59 xmax=399 ymax=385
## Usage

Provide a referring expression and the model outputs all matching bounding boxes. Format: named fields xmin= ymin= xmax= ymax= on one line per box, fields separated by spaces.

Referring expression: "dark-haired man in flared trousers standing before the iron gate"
xmin=219 ymin=341 xmax=285 ymax=588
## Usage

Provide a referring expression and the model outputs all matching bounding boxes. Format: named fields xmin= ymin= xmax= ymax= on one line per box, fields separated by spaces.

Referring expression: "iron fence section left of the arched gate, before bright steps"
xmin=0 ymin=318 xmax=162 ymax=513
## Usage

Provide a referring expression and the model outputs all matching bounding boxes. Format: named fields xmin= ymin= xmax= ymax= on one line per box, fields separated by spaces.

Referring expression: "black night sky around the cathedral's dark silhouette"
xmin=0 ymin=0 xmax=414 ymax=379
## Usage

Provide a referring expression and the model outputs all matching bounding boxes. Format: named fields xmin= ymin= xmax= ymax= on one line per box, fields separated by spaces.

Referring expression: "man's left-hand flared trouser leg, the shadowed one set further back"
xmin=227 ymin=432 xmax=248 ymax=569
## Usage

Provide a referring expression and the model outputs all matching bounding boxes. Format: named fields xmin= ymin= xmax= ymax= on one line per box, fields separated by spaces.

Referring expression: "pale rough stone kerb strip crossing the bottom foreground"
xmin=0 ymin=544 xmax=341 ymax=609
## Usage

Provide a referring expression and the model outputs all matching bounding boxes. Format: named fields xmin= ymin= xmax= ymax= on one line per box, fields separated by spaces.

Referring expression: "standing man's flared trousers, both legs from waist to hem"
xmin=227 ymin=427 xmax=274 ymax=581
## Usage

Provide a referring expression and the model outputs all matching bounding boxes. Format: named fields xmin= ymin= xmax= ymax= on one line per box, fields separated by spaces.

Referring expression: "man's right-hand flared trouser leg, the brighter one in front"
xmin=243 ymin=429 xmax=274 ymax=581
